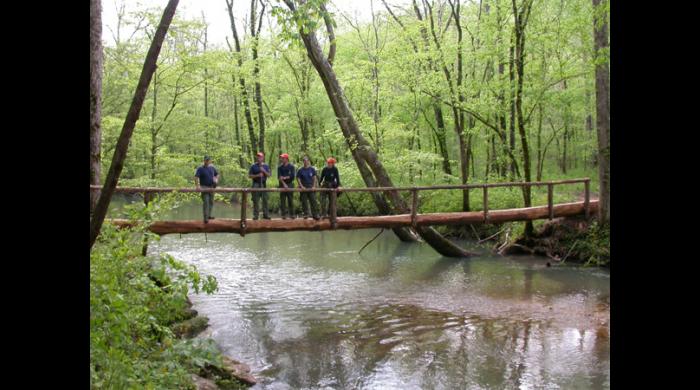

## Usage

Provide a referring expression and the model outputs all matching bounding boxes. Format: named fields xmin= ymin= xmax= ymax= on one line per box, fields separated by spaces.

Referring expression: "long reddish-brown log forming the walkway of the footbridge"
xmin=108 ymin=200 xmax=598 ymax=235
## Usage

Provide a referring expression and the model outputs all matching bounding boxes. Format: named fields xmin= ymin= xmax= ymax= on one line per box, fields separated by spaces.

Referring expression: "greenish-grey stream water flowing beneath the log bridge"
xmin=127 ymin=203 xmax=610 ymax=390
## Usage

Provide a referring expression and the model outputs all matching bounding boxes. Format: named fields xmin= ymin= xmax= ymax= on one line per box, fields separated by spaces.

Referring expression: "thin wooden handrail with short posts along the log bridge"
xmin=90 ymin=177 xmax=591 ymax=234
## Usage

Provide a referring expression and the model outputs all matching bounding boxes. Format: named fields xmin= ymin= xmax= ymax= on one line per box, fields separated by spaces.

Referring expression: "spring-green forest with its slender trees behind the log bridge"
xmin=94 ymin=0 xmax=609 ymax=253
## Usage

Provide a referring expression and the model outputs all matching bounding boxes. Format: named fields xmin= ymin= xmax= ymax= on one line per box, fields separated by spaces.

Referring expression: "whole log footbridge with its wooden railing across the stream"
xmin=90 ymin=178 xmax=598 ymax=236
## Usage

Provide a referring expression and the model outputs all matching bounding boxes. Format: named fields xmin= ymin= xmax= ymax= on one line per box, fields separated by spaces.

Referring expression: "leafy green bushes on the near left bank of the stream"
xmin=90 ymin=197 xmax=249 ymax=389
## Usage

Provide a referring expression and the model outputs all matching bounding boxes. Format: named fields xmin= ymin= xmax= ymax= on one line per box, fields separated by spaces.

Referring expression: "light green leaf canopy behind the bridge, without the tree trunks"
xmin=97 ymin=0 xmax=597 ymax=195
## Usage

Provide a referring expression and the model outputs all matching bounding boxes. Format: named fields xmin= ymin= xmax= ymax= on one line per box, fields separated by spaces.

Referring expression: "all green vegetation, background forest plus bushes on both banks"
xmin=90 ymin=0 xmax=609 ymax=388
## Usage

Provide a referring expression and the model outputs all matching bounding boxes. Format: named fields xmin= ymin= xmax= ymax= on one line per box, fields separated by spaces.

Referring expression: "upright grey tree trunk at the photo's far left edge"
xmin=90 ymin=0 xmax=102 ymax=212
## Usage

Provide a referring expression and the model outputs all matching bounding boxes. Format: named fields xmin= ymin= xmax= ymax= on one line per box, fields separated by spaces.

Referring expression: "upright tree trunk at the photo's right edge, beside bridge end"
xmin=593 ymin=0 xmax=610 ymax=224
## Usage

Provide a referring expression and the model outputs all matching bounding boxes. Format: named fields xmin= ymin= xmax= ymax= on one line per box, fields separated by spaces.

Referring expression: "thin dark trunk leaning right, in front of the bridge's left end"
xmin=90 ymin=0 xmax=179 ymax=249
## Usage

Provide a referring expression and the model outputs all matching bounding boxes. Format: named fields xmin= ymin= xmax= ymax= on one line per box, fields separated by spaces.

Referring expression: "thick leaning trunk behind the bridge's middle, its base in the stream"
xmin=285 ymin=0 xmax=472 ymax=257
